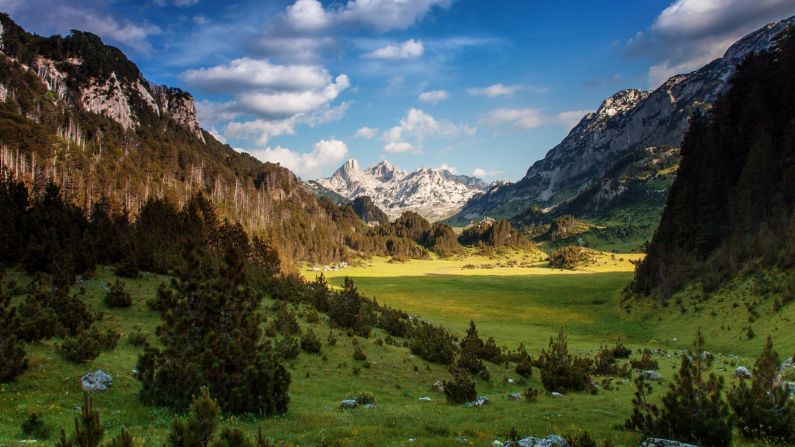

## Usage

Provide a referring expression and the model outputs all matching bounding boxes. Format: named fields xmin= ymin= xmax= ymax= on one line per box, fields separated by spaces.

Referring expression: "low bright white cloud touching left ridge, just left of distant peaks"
xmin=247 ymin=138 xmax=348 ymax=179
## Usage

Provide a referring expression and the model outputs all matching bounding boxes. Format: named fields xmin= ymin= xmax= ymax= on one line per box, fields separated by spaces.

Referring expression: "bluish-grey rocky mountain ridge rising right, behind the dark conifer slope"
xmin=451 ymin=17 xmax=795 ymax=223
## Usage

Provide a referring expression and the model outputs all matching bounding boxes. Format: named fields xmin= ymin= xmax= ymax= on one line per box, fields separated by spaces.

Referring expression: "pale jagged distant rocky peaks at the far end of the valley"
xmin=314 ymin=160 xmax=487 ymax=221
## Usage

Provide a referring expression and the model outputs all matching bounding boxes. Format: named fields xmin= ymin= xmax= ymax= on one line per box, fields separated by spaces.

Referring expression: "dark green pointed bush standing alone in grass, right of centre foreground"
xmin=538 ymin=331 xmax=591 ymax=392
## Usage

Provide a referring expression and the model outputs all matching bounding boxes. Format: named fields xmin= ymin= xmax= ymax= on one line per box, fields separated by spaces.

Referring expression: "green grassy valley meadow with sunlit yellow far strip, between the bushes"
xmin=0 ymin=253 xmax=795 ymax=446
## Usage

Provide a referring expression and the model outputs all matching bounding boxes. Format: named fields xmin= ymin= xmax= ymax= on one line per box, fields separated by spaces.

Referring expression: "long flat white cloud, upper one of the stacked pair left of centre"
xmin=182 ymin=57 xmax=331 ymax=93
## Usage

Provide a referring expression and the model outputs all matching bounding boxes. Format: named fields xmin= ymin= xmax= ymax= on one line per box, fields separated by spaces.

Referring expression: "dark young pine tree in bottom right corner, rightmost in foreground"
xmin=728 ymin=336 xmax=795 ymax=443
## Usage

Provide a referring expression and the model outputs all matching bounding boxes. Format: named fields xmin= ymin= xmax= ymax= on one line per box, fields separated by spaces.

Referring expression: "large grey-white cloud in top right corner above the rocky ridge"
xmin=627 ymin=0 xmax=795 ymax=87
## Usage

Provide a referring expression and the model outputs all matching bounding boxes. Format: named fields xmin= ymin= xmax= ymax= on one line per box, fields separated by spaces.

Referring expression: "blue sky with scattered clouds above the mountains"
xmin=0 ymin=0 xmax=795 ymax=181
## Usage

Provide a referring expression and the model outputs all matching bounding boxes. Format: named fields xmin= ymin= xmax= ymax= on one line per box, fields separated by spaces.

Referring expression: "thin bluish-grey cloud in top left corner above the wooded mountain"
xmin=0 ymin=0 xmax=161 ymax=53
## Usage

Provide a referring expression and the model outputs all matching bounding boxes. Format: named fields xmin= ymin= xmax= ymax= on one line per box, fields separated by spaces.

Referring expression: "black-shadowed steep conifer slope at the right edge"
xmin=632 ymin=31 xmax=795 ymax=299
